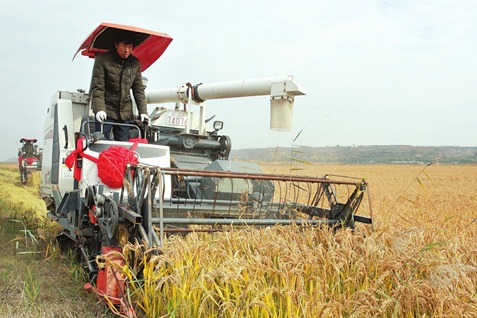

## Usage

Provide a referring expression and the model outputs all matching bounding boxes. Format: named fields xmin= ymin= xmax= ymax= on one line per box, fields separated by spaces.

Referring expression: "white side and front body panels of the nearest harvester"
xmin=40 ymin=91 xmax=171 ymax=207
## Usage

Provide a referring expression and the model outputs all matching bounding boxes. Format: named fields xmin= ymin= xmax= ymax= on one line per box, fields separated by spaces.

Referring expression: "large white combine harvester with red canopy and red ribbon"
xmin=41 ymin=23 xmax=372 ymax=314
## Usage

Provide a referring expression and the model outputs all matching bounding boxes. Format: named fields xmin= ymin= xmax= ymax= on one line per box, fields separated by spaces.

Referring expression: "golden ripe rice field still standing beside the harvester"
xmin=3 ymin=164 xmax=477 ymax=317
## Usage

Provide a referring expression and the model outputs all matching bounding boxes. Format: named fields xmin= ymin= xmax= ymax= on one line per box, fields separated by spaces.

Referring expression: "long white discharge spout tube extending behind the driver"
xmin=146 ymin=75 xmax=305 ymax=131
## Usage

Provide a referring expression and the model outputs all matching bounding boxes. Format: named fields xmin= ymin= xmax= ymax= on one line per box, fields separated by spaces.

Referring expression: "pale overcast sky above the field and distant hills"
xmin=0 ymin=0 xmax=477 ymax=161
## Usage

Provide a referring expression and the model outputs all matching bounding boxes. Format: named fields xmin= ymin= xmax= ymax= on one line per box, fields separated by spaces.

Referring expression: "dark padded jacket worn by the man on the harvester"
xmin=90 ymin=49 xmax=147 ymax=121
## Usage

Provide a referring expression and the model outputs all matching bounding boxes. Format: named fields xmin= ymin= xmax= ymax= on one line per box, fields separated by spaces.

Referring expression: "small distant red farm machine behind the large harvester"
xmin=18 ymin=138 xmax=42 ymax=184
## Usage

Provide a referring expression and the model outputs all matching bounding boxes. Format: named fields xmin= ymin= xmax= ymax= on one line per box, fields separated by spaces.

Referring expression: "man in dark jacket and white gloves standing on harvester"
xmin=90 ymin=30 xmax=150 ymax=141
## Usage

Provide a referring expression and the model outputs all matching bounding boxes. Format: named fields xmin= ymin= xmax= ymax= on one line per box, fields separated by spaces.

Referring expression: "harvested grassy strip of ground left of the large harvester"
xmin=0 ymin=165 xmax=113 ymax=318
